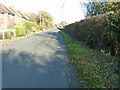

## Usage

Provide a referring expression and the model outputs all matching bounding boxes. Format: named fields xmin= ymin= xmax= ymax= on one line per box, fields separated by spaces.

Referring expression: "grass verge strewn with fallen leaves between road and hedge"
xmin=61 ymin=31 xmax=118 ymax=88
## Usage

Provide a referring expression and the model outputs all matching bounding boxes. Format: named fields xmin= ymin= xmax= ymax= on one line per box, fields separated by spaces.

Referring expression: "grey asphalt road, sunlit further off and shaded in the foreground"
xmin=2 ymin=29 xmax=75 ymax=88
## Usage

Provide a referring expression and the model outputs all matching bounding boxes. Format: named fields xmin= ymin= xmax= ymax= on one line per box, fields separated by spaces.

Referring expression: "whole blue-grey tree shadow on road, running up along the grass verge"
xmin=2 ymin=29 xmax=76 ymax=88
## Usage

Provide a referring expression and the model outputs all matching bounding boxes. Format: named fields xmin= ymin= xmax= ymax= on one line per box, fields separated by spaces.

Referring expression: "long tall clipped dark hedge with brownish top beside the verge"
xmin=63 ymin=12 xmax=120 ymax=56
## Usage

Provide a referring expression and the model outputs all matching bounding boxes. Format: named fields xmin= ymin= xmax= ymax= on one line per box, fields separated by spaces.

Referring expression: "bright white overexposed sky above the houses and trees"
xmin=0 ymin=0 xmax=85 ymax=23
